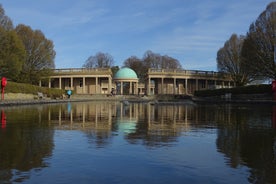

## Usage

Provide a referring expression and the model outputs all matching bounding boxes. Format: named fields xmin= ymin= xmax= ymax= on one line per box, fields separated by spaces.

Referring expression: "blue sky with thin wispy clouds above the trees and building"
xmin=0 ymin=0 xmax=272 ymax=71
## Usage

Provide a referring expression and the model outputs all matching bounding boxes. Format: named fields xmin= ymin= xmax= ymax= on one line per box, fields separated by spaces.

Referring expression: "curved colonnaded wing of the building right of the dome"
xmin=145 ymin=69 xmax=235 ymax=95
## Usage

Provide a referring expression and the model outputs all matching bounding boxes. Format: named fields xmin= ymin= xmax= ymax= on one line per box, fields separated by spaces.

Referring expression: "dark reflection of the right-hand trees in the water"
xmin=217 ymin=106 xmax=276 ymax=183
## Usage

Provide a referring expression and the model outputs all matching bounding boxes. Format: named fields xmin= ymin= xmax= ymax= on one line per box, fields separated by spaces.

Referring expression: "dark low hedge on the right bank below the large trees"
xmin=194 ymin=84 xmax=272 ymax=97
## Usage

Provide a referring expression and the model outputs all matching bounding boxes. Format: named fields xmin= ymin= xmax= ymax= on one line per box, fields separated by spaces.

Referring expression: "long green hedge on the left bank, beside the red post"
xmin=5 ymin=81 xmax=65 ymax=98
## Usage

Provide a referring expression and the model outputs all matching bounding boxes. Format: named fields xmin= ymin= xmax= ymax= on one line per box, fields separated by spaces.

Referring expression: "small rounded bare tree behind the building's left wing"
xmin=83 ymin=52 xmax=114 ymax=68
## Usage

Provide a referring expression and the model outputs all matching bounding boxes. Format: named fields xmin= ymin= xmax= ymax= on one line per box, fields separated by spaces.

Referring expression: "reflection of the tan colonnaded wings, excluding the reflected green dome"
xmin=48 ymin=102 xmax=240 ymax=135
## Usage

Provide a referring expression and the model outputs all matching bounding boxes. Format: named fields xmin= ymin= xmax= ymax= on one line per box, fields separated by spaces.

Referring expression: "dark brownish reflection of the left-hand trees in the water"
xmin=0 ymin=108 xmax=53 ymax=182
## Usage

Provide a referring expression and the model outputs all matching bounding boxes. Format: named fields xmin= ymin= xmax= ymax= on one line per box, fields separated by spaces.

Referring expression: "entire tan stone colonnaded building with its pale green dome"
xmin=40 ymin=67 xmax=235 ymax=95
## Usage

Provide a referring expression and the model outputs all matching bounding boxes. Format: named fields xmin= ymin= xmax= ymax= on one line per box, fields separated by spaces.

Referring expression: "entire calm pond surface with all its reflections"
xmin=0 ymin=102 xmax=276 ymax=184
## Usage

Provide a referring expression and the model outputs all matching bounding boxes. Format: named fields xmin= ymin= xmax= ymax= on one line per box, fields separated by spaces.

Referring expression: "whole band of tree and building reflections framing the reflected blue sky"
xmin=0 ymin=102 xmax=276 ymax=183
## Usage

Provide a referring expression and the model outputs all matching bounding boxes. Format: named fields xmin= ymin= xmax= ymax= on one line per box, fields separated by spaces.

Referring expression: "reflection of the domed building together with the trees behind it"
xmin=48 ymin=102 xmax=236 ymax=150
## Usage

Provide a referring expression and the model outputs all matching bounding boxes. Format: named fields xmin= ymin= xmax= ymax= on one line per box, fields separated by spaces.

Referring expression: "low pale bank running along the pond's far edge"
xmin=0 ymin=94 xmax=276 ymax=107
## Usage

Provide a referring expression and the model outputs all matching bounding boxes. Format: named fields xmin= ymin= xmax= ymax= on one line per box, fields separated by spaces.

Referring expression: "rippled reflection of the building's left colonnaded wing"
xmin=48 ymin=103 xmax=115 ymax=131
